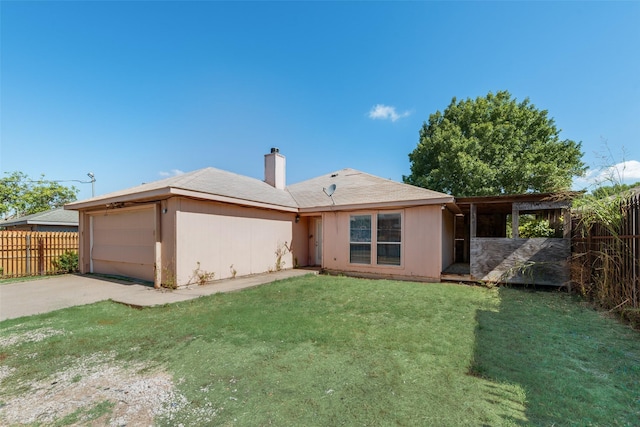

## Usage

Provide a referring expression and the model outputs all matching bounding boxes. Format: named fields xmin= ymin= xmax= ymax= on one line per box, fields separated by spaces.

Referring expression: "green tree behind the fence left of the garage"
xmin=0 ymin=172 xmax=78 ymax=218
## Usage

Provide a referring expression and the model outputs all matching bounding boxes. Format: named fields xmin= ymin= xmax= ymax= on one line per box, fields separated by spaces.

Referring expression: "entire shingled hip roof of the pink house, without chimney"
xmin=66 ymin=168 xmax=455 ymax=212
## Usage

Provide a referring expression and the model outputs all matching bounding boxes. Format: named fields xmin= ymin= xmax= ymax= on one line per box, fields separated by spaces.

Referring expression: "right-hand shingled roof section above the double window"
xmin=287 ymin=169 xmax=453 ymax=212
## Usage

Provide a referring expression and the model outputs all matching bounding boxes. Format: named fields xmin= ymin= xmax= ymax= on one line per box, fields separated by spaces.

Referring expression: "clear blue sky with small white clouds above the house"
xmin=0 ymin=1 xmax=640 ymax=199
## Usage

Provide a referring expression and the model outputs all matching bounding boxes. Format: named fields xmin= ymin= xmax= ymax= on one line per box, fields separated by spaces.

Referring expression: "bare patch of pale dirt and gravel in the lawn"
xmin=0 ymin=354 xmax=187 ymax=426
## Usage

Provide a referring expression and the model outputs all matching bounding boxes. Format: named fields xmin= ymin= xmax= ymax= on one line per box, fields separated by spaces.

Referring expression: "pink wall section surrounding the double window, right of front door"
xmin=322 ymin=205 xmax=453 ymax=281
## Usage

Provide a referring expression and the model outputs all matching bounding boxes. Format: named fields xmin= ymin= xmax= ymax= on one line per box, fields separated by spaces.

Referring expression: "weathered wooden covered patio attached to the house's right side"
xmin=441 ymin=193 xmax=571 ymax=286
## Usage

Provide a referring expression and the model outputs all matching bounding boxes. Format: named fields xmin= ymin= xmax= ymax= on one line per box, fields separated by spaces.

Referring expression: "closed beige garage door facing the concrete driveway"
xmin=91 ymin=207 xmax=155 ymax=281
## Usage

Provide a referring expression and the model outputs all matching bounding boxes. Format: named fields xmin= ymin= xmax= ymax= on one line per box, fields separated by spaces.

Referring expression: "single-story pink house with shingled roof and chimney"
xmin=65 ymin=148 xmax=460 ymax=286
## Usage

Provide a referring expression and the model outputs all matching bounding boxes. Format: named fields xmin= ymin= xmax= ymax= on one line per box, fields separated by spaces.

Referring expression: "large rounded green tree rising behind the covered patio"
xmin=403 ymin=91 xmax=586 ymax=197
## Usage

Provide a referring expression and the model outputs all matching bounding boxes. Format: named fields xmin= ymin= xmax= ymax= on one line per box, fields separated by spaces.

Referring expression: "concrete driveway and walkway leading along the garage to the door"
xmin=0 ymin=269 xmax=318 ymax=321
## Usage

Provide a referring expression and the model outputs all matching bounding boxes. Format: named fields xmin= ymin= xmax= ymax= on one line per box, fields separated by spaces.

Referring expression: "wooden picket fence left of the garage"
xmin=0 ymin=230 xmax=78 ymax=278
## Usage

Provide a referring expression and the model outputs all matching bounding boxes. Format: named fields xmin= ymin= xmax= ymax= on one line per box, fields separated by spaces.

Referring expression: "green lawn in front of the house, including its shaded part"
xmin=0 ymin=276 xmax=640 ymax=426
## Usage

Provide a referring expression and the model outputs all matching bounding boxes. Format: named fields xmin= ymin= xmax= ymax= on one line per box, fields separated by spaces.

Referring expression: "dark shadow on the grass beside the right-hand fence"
xmin=470 ymin=288 xmax=640 ymax=425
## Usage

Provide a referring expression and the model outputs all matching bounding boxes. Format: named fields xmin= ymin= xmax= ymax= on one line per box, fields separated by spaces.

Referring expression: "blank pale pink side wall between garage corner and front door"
xmin=174 ymin=198 xmax=306 ymax=285
